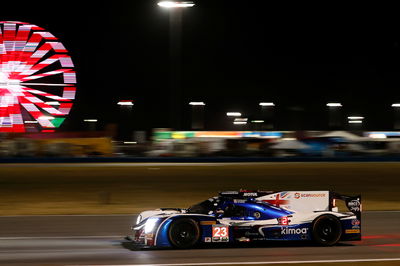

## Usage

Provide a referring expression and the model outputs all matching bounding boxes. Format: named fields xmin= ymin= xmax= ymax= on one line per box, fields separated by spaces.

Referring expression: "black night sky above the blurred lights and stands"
xmin=0 ymin=0 xmax=400 ymax=130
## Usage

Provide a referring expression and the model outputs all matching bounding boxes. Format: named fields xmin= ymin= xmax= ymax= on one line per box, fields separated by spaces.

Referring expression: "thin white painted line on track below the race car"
xmin=79 ymin=258 xmax=400 ymax=266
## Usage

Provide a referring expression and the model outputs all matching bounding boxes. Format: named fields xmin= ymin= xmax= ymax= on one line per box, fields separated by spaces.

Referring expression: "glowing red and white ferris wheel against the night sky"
xmin=0 ymin=21 xmax=76 ymax=132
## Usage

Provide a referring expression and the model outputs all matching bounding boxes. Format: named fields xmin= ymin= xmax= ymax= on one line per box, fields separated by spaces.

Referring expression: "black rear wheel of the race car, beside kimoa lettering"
xmin=312 ymin=215 xmax=342 ymax=246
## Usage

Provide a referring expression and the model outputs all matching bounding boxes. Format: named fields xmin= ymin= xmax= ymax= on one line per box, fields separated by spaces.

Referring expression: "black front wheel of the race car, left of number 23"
xmin=168 ymin=218 xmax=200 ymax=249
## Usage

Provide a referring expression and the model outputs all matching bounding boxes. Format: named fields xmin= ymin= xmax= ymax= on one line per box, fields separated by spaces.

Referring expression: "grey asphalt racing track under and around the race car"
xmin=0 ymin=212 xmax=400 ymax=265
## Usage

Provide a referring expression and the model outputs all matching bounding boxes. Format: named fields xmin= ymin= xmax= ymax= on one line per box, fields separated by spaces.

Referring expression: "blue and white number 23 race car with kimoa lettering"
xmin=127 ymin=190 xmax=362 ymax=249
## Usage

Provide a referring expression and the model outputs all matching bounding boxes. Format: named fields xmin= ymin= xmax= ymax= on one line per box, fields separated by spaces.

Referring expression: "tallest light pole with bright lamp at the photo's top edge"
xmin=158 ymin=1 xmax=195 ymax=130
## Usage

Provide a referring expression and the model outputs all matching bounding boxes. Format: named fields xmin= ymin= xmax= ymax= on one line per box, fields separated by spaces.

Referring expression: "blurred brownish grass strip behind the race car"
xmin=0 ymin=163 xmax=400 ymax=215
